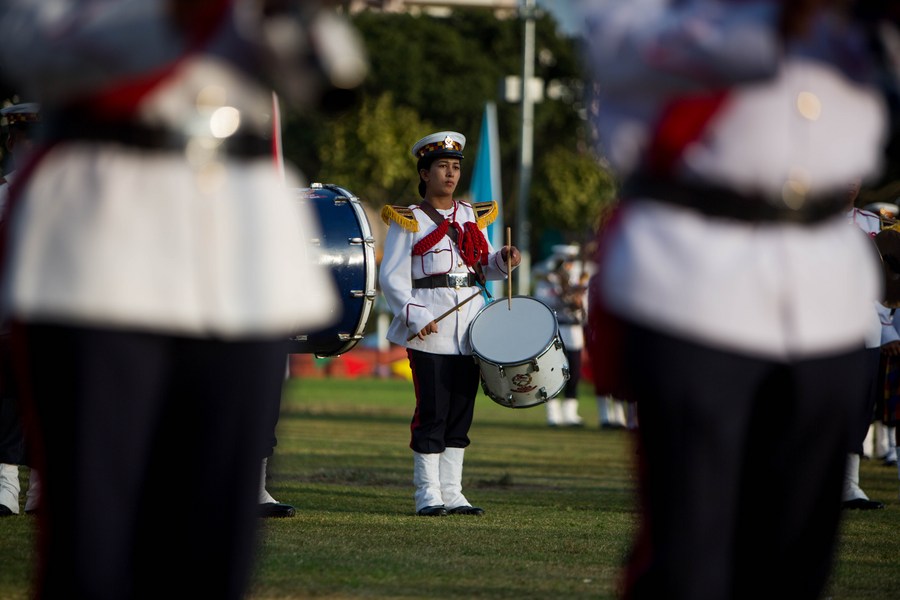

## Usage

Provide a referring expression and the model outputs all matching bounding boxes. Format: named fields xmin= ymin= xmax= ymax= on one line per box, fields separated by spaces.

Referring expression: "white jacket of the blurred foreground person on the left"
xmin=0 ymin=0 xmax=336 ymax=338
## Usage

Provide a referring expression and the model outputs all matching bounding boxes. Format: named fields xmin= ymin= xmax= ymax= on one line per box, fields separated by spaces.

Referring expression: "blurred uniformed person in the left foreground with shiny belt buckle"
xmin=0 ymin=0 xmax=352 ymax=599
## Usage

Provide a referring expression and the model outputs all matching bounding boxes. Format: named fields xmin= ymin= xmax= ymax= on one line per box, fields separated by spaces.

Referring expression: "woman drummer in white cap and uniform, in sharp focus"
xmin=379 ymin=131 xmax=525 ymax=516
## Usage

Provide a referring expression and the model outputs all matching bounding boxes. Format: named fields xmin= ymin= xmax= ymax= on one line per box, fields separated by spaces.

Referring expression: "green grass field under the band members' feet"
xmin=0 ymin=379 xmax=900 ymax=600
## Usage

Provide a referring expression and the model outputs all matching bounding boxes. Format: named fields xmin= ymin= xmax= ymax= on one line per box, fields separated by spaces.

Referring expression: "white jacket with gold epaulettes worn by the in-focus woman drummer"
xmin=379 ymin=200 xmax=509 ymax=354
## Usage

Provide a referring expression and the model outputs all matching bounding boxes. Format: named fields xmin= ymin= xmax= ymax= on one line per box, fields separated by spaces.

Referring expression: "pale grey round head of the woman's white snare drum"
xmin=469 ymin=296 xmax=559 ymax=365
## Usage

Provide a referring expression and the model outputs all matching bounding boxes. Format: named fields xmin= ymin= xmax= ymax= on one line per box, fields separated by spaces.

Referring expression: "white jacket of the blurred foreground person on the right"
xmin=583 ymin=0 xmax=887 ymax=359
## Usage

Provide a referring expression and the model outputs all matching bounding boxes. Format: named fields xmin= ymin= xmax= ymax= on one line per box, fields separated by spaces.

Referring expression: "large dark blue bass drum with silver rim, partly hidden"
xmin=288 ymin=183 xmax=376 ymax=356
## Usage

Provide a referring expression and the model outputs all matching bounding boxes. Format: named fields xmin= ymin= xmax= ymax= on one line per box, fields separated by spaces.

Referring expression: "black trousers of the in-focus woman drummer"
xmin=406 ymin=349 xmax=480 ymax=454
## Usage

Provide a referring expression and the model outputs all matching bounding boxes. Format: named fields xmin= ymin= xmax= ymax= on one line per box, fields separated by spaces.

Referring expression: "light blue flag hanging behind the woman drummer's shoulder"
xmin=469 ymin=102 xmax=506 ymax=298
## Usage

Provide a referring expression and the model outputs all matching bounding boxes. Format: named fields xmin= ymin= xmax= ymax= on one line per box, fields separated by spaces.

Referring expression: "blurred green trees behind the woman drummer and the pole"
xmin=284 ymin=9 xmax=602 ymax=252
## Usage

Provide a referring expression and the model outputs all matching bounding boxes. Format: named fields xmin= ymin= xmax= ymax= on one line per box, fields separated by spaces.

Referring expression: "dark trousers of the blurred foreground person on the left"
xmin=16 ymin=325 xmax=286 ymax=600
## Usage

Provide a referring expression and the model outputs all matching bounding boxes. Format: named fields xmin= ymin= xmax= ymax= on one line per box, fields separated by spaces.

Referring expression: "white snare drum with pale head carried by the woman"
xmin=469 ymin=296 xmax=569 ymax=408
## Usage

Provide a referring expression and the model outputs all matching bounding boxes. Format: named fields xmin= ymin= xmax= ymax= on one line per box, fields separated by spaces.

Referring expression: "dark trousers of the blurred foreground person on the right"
xmin=625 ymin=327 xmax=865 ymax=600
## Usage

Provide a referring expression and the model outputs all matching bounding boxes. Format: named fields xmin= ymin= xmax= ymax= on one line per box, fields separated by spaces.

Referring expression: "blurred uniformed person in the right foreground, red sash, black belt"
xmin=582 ymin=0 xmax=888 ymax=599
